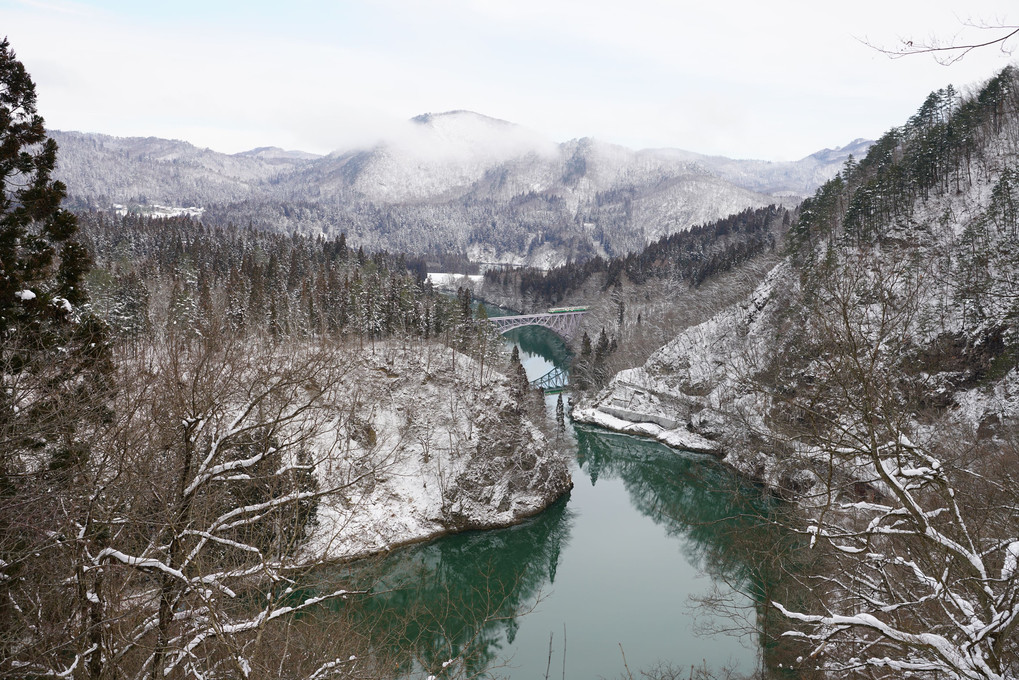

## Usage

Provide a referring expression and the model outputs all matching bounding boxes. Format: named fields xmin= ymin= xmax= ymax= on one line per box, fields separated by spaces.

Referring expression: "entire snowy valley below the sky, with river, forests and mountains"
xmin=0 ymin=22 xmax=1019 ymax=680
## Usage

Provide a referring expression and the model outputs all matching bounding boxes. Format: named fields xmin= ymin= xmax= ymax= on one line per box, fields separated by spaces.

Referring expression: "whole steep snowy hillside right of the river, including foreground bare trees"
xmin=574 ymin=68 xmax=1019 ymax=678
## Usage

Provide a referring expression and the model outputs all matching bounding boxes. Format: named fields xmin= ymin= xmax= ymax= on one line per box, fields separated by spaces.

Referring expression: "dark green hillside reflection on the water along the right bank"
xmin=575 ymin=426 xmax=798 ymax=676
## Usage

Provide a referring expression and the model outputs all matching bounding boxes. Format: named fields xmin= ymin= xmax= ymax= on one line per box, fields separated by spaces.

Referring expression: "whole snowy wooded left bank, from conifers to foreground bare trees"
xmin=0 ymin=201 xmax=572 ymax=678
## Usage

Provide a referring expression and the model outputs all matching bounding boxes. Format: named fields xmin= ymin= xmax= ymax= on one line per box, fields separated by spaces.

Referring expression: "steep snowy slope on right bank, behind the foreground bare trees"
xmin=574 ymin=69 xmax=1019 ymax=487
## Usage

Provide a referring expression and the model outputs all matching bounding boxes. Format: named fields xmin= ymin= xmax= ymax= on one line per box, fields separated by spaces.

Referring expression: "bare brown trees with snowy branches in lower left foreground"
xmin=4 ymin=326 xmax=397 ymax=679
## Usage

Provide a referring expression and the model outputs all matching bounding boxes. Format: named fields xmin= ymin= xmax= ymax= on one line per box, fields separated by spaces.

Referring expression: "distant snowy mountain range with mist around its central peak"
xmin=52 ymin=111 xmax=869 ymax=266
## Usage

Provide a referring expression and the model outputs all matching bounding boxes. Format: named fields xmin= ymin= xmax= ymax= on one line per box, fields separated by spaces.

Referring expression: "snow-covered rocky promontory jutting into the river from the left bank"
xmin=307 ymin=343 xmax=573 ymax=559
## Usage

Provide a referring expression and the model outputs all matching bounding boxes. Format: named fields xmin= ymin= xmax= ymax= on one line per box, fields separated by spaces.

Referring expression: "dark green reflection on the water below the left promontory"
xmin=334 ymin=499 xmax=572 ymax=677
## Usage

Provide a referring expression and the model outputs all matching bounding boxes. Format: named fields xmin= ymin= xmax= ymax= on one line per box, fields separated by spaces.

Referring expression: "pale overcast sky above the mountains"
xmin=0 ymin=0 xmax=1019 ymax=160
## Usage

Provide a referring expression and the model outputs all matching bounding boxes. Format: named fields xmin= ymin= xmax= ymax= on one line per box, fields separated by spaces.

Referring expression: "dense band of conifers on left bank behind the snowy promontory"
xmin=79 ymin=213 xmax=485 ymax=348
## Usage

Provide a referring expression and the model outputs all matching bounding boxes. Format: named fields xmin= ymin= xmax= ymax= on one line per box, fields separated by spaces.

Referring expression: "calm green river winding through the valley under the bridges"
xmin=334 ymin=316 xmax=770 ymax=680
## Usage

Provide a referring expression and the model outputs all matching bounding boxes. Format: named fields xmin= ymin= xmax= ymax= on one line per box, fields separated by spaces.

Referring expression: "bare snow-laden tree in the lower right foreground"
xmin=770 ymin=249 xmax=1019 ymax=679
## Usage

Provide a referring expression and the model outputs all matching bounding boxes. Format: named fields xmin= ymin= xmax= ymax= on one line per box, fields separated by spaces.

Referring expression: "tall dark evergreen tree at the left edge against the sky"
xmin=0 ymin=40 xmax=109 ymax=473
